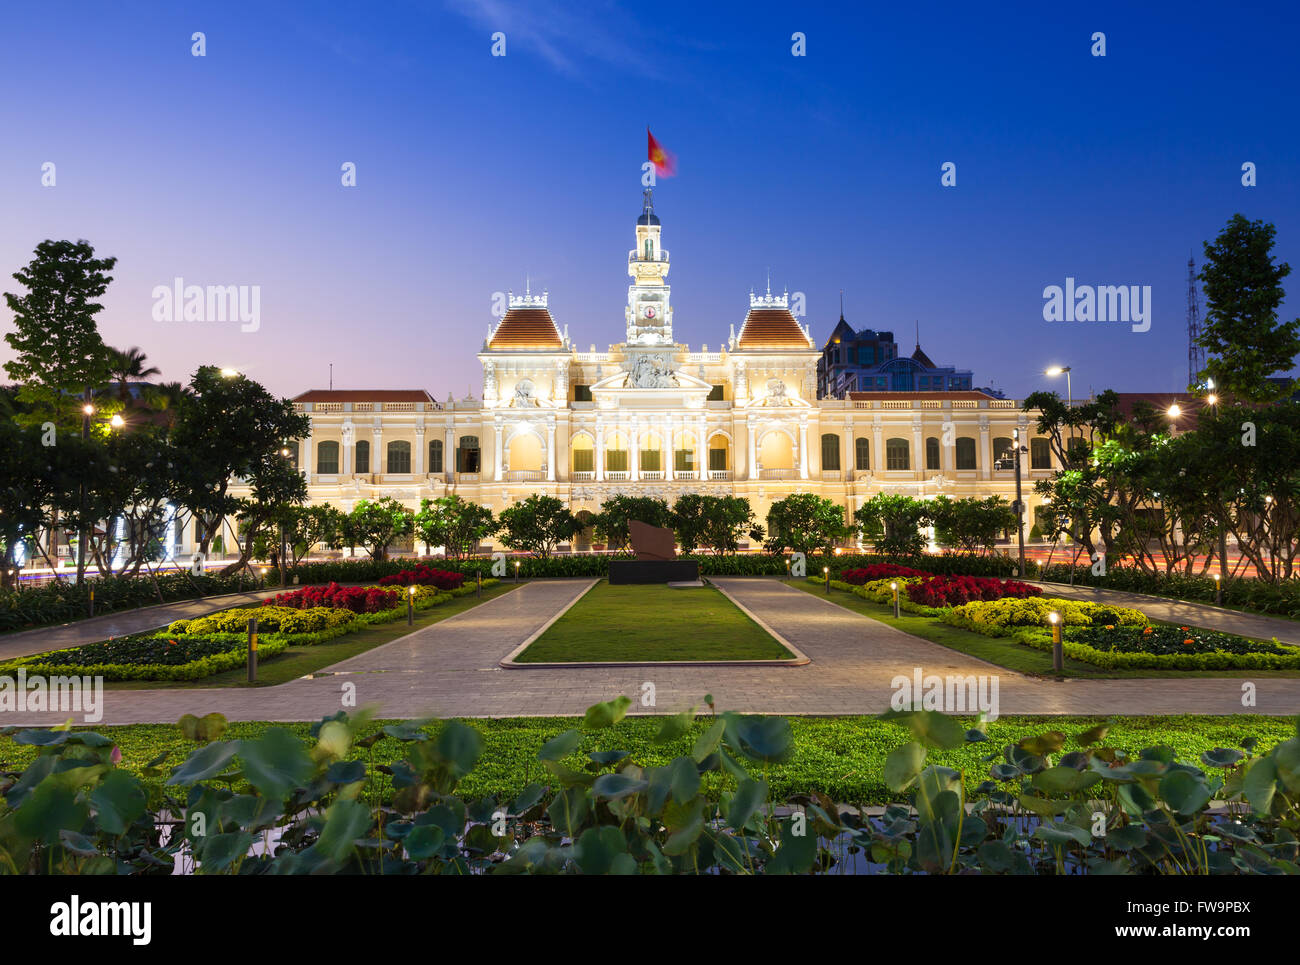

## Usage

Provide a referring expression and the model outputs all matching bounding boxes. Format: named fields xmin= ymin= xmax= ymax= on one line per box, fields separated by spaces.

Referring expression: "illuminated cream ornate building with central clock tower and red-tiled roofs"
xmin=248 ymin=190 xmax=1052 ymax=549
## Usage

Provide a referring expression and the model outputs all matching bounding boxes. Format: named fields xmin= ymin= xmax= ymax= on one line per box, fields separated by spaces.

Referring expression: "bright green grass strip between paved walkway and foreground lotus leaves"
xmin=0 ymin=712 xmax=1296 ymax=804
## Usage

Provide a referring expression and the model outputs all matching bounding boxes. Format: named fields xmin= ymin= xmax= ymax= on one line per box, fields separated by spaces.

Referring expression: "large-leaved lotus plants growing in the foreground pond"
xmin=0 ymin=697 xmax=1300 ymax=875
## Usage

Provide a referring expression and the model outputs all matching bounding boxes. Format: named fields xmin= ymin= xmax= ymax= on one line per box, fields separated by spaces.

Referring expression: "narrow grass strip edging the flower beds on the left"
xmin=104 ymin=583 xmax=524 ymax=691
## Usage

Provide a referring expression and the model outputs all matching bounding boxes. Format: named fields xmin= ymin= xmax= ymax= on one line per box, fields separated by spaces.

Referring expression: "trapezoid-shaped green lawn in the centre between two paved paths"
xmin=515 ymin=580 xmax=794 ymax=663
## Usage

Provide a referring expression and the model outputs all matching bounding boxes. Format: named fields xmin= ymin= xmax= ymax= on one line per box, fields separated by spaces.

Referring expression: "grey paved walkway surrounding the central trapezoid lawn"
xmin=0 ymin=577 xmax=1300 ymax=724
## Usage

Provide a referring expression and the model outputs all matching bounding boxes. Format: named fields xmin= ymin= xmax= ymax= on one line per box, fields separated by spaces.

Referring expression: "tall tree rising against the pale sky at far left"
xmin=5 ymin=241 xmax=117 ymax=427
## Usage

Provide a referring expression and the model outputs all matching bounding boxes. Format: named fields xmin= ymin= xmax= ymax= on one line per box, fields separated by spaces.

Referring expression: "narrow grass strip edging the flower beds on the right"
xmin=784 ymin=580 xmax=1297 ymax=679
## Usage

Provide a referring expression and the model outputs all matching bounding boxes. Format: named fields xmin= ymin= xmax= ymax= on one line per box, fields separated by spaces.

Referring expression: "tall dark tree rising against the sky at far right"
xmin=1197 ymin=215 xmax=1300 ymax=402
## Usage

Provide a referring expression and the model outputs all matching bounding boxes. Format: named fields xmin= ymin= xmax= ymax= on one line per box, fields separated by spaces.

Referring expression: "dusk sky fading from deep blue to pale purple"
xmin=0 ymin=0 xmax=1300 ymax=398
